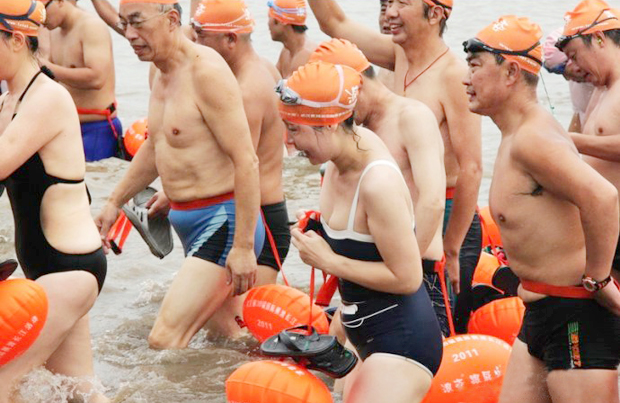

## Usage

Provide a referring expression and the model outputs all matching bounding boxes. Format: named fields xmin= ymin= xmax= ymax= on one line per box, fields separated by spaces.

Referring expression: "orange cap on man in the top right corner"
xmin=556 ymin=0 xmax=620 ymax=49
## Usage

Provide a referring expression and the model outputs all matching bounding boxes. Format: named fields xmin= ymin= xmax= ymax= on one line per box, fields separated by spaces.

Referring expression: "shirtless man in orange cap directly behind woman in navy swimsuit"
xmin=310 ymin=39 xmax=446 ymax=268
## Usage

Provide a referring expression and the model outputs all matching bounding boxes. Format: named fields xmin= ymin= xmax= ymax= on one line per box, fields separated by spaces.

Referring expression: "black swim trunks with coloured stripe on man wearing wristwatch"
xmin=519 ymin=297 xmax=620 ymax=371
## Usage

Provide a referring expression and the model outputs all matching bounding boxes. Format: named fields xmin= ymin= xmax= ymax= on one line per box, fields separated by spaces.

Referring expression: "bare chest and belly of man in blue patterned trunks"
xmin=148 ymin=45 xmax=243 ymax=202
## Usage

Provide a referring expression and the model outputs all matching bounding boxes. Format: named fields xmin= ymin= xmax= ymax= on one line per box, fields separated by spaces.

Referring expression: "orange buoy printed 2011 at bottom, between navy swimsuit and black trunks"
xmin=422 ymin=334 xmax=511 ymax=403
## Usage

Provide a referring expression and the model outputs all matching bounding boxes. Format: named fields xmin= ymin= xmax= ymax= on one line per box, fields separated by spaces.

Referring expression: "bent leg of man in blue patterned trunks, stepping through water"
xmin=149 ymin=257 xmax=234 ymax=349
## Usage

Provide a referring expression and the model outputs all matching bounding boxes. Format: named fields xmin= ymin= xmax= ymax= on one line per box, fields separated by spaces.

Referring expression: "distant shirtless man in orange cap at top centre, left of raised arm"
xmin=268 ymin=0 xmax=316 ymax=78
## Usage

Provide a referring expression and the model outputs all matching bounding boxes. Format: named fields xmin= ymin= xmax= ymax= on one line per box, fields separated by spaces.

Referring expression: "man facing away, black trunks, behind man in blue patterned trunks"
xmin=191 ymin=0 xmax=291 ymax=285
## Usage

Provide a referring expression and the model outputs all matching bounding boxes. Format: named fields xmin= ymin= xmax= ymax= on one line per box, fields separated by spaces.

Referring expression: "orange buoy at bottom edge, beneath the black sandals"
xmin=226 ymin=361 xmax=333 ymax=403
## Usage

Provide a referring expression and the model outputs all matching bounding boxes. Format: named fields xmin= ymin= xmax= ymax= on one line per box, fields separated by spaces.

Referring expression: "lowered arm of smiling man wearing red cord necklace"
xmin=443 ymin=66 xmax=482 ymax=259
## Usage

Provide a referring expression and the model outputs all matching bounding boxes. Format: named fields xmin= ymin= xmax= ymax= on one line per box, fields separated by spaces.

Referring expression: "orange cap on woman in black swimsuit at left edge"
xmin=0 ymin=0 xmax=46 ymax=36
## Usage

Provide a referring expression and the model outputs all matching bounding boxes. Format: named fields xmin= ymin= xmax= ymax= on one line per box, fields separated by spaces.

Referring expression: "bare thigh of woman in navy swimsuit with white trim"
xmin=344 ymin=354 xmax=431 ymax=403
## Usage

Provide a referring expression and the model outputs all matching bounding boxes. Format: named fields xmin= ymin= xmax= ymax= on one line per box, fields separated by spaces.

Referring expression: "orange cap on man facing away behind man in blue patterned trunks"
xmin=192 ymin=0 xmax=254 ymax=34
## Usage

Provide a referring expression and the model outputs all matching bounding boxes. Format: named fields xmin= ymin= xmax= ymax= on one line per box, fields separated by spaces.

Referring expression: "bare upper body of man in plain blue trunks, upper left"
xmin=50 ymin=8 xmax=116 ymax=122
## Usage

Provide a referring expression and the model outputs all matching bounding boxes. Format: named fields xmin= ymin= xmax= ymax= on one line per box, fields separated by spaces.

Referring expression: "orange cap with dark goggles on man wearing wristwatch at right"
xmin=463 ymin=15 xmax=543 ymax=74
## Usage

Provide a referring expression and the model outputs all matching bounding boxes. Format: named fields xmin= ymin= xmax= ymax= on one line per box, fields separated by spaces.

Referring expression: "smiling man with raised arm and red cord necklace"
xmin=309 ymin=0 xmax=482 ymax=334
